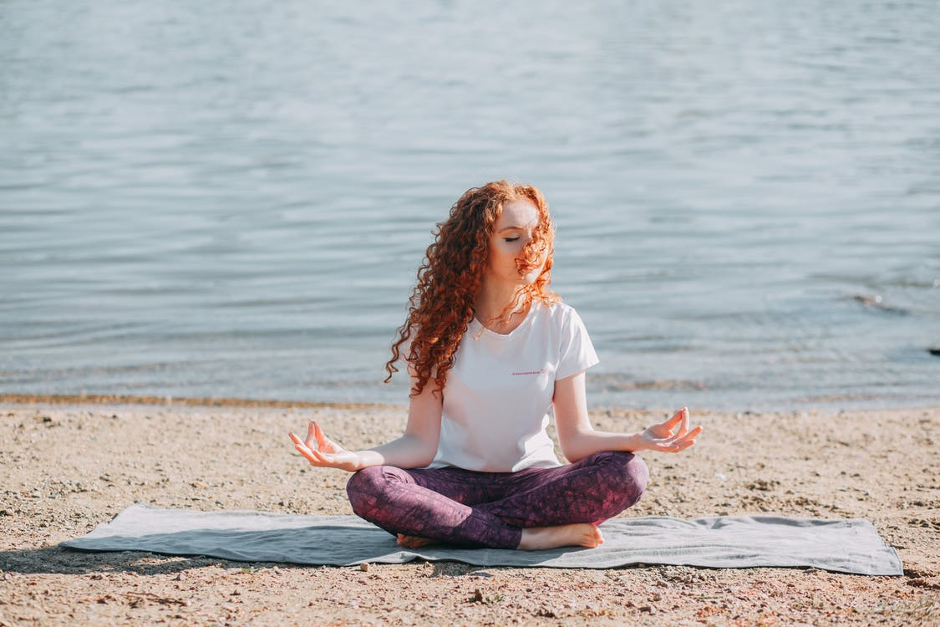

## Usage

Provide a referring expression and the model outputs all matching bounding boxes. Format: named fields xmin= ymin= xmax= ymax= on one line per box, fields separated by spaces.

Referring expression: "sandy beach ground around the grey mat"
xmin=0 ymin=397 xmax=939 ymax=626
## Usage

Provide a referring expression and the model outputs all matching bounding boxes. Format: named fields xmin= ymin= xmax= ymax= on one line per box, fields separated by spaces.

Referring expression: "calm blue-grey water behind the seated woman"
xmin=0 ymin=0 xmax=939 ymax=409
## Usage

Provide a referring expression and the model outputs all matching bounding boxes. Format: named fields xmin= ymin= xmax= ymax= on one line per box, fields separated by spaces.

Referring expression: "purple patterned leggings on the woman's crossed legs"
xmin=346 ymin=451 xmax=648 ymax=549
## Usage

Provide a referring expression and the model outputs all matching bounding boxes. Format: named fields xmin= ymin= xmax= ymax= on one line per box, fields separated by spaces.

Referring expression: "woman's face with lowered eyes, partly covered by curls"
xmin=487 ymin=200 xmax=546 ymax=286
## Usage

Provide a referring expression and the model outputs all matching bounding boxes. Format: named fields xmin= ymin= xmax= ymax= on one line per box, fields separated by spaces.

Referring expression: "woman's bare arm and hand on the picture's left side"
xmin=290 ymin=369 xmax=442 ymax=472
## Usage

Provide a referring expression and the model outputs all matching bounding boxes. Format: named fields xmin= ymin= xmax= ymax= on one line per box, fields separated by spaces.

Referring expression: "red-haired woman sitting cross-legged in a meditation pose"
xmin=290 ymin=181 xmax=702 ymax=550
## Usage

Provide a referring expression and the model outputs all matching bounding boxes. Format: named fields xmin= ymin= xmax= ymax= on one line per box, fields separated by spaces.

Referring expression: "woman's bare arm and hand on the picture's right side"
xmin=552 ymin=370 xmax=702 ymax=463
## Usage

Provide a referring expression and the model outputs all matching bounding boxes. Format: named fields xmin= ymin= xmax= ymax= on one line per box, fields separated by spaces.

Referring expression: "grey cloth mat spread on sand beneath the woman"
xmin=60 ymin=504 xmax=902 ymax=575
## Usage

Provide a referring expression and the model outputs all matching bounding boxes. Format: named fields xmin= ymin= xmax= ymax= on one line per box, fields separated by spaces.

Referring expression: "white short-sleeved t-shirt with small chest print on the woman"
xmin=408 ymin=300 xmax=598 ymax=472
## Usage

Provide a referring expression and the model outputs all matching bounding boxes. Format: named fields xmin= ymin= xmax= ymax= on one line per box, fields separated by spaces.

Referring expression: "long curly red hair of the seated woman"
xmin=385 ymin=180 xmax=561 ymax=396
